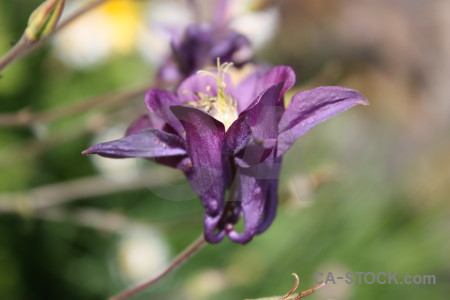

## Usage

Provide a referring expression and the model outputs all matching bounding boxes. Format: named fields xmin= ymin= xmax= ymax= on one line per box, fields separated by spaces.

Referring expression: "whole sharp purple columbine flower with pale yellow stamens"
xmin=83 ymin=64 xmax=368 ymax=244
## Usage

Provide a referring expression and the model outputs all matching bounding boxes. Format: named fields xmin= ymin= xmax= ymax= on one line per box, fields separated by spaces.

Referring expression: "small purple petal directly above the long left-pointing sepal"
xmin=145 ymin=89 xmax=183 ymax=136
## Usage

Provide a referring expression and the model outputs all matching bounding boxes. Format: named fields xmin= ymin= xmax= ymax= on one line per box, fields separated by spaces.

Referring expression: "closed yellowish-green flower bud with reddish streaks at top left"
xmin=25 ymin=0 xmax=66 ymax=42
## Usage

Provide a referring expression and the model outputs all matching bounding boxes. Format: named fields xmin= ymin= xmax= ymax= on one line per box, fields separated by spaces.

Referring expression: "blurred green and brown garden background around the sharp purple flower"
xmin=0 ymin=0 xmax=450 ymax=300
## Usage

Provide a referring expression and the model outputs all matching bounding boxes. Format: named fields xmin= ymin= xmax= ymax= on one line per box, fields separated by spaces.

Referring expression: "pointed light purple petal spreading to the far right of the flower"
xmin=277 ymin=86 xmax=369 ymax=156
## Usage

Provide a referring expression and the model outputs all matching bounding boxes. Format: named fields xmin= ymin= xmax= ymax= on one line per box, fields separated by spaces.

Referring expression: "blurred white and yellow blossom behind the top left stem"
xmin=54 ymin=0 xmax=144 ymax=68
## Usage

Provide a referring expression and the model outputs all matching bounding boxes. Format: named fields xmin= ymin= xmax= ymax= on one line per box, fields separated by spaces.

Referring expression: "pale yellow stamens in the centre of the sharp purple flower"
xmin=187 ymin=59 xmax=238 ymax=130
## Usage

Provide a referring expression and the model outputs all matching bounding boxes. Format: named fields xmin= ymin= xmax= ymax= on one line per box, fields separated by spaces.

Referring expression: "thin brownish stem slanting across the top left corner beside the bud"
xmin=0 ymin=0 xmax=109 ymax=71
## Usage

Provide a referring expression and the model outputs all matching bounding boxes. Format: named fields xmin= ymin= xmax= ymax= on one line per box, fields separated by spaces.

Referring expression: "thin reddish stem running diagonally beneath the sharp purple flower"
xmin=109 ymin=235 xmax=206 ymax=300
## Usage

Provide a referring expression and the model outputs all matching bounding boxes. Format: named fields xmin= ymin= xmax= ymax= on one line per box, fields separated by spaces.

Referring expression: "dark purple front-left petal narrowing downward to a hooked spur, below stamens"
xmin=171 ymin=106 xmax=229 ymax=242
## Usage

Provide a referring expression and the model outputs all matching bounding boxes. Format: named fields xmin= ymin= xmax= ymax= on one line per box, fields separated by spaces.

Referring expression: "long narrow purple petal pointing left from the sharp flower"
xmin=83 ymin=129 xmax=187 ymax=158
